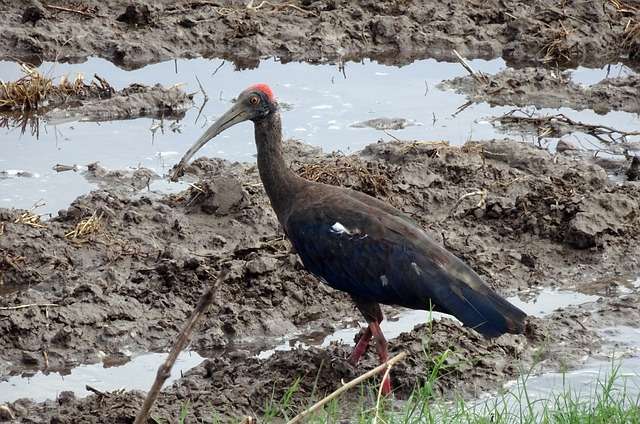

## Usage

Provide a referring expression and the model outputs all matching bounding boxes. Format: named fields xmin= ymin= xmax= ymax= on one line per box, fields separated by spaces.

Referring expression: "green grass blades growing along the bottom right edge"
xmin=164 ymin=322 xmax=640 ymax=424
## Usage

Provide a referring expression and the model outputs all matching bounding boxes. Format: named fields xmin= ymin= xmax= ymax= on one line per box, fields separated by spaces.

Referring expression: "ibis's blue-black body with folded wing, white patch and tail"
xmin=284 ymin=196 xmax=524 ymax=336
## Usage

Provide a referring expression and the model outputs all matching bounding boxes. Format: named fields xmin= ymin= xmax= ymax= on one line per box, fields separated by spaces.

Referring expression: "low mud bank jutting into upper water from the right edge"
xmin=441 ymin=68 xmax=640 ymax=114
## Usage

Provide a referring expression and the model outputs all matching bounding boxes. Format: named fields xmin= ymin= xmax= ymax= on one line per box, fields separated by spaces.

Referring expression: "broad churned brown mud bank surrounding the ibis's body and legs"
xmin=0 ymin=140 xmax=640 ymax=422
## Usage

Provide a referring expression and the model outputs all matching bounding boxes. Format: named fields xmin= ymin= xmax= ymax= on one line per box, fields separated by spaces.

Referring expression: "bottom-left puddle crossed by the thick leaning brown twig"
xmin=0 ymin=352 xmax=204 ymax=403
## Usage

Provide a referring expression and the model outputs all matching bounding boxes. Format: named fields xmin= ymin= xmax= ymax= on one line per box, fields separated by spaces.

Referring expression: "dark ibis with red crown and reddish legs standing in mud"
xmin=172 ymin=84 xmax=526 ymax=393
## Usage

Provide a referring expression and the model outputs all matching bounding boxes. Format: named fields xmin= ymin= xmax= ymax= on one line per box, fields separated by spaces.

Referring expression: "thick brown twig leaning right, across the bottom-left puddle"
xmin=134 ymin=272 xmax=226 ymax=424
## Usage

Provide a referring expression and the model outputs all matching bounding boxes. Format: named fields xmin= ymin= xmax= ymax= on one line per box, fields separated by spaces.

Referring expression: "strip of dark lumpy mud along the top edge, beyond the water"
xmin=0 ymin=0 xmax=640 ymax=69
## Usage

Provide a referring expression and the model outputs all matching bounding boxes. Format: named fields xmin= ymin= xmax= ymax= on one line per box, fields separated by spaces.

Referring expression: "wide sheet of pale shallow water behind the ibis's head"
xmin=0 ymin=59 xmax=638 ymax=213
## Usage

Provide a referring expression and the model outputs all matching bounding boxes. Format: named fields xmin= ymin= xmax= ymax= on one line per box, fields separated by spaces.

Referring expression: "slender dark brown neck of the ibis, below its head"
xmin=255 ymin=111 xmax=305 ymax=223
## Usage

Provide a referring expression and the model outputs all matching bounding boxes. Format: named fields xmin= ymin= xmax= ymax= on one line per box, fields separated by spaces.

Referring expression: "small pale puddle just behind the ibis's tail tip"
xmin=507 ymin=288 xmax=600 ymax=317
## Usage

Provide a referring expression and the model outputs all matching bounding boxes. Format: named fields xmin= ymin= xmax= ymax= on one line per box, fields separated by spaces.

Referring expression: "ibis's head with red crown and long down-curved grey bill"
xmin=171 ymin=84 xmax=278 ymax=181
